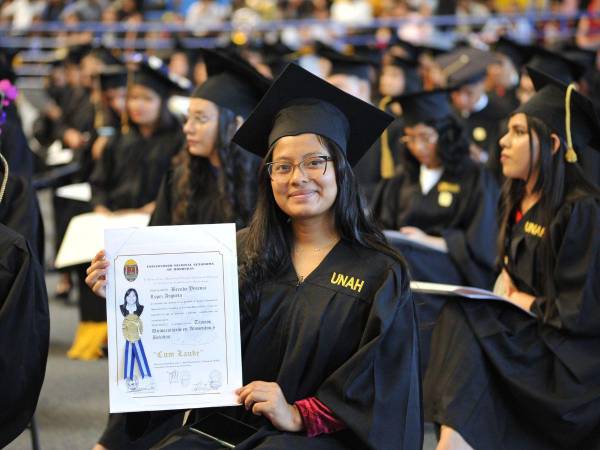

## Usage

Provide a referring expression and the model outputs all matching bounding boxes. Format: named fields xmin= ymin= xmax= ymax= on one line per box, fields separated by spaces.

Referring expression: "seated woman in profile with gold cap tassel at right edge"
xmin=424 ymin=70 xmax=600 ymax=450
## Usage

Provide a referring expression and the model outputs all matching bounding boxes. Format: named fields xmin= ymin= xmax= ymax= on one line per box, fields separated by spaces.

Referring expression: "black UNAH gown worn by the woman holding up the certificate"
xmin=100 ymin=234 xmax=423 ymax=450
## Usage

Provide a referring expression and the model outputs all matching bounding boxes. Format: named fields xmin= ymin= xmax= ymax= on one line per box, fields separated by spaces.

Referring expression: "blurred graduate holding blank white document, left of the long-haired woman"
xmin=67 ymin=60 xmax=183 ymax=360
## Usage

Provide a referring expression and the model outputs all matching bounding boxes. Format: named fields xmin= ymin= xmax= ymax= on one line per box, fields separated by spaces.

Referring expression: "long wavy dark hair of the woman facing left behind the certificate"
xmin=172 ymin=106 xmax=259 ymax=228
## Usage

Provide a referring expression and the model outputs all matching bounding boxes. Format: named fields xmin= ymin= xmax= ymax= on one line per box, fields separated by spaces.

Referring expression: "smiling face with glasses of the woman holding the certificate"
xmin=271 ymin=134 xmax=338 ymax=220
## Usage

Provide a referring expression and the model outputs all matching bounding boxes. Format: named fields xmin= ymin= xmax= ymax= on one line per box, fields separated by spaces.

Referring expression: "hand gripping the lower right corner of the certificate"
xmin=235 ymin=381 xmax=304 ymax=432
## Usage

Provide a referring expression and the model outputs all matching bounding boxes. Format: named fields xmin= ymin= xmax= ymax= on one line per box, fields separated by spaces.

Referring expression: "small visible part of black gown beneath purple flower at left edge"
xmin=0 ymin=174 xmax=44 ymax=262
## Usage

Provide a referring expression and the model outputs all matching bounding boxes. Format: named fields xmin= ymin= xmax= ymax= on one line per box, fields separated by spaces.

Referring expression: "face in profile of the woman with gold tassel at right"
xmin=500 ymin=113 xmax=539 ymax=181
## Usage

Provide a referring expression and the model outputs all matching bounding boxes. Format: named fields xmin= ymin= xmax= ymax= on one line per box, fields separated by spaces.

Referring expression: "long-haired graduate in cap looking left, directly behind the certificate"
xmin=150 ymin=50 xmax=270 ymax=228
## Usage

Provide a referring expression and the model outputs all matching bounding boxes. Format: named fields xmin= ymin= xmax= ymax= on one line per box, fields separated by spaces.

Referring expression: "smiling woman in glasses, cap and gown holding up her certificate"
xmin=87 ymin=64 xmax=423 ymax=450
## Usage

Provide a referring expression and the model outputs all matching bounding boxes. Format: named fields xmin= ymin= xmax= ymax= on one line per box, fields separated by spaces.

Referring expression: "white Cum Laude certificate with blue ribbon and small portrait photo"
xmin=104 ymin=224 xmax=242 ymax=413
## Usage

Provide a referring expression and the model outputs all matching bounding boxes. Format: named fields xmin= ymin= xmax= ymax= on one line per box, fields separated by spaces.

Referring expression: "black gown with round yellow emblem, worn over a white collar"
xmin=374 ymin=160 xmax=498 ymax=289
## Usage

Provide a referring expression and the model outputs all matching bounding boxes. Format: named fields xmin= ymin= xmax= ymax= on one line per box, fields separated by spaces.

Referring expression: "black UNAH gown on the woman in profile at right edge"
xmin=424 ymin=192 xmax=600 ymax=450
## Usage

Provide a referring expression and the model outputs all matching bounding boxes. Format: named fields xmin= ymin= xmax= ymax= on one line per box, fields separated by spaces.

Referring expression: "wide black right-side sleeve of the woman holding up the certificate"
xmin=316 ymin=264 xmax=423 ymax=450
